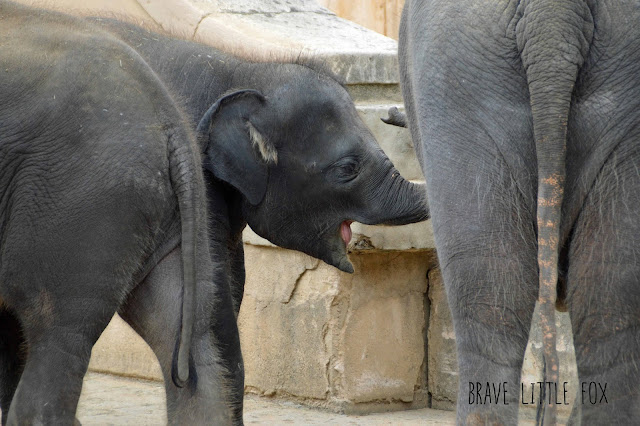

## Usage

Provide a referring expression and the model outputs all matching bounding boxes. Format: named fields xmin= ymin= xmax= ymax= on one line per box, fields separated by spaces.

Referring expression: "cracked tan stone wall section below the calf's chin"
xmin=239 ymin=246 xmax=434 ymax=412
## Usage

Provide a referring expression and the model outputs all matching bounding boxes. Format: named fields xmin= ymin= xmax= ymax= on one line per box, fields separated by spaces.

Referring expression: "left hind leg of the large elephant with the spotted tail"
xmin=399 ymin=2 xmax=539 ymax=425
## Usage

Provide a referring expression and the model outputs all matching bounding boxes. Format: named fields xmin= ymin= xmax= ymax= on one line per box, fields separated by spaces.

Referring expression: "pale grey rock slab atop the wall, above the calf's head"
xmin=191 ymin=0 xmax=399 ymax=84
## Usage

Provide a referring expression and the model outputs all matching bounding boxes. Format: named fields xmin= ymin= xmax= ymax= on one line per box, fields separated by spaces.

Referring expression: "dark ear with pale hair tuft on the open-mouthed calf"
xmin=198 ymin=89 xmax=278 ymax=206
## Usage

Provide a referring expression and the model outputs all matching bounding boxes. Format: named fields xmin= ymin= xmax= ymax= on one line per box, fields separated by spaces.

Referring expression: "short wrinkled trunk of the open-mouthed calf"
xmin=355 ymin=159 xmax=430 ymax=225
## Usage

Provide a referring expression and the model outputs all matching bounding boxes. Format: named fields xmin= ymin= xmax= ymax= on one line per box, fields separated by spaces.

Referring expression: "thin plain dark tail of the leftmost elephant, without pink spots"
xmin=169 ymin=125 xmax=203 ymax=387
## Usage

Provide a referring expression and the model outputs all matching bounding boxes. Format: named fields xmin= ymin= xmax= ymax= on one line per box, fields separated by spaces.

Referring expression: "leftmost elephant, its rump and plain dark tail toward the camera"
xmin=0 ymin=2 xmax=237 ymax=424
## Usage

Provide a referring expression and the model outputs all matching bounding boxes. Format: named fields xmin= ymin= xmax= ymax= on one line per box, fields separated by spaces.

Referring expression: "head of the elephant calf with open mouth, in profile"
xmin=198 ymin=64 xmax=429 ymax=272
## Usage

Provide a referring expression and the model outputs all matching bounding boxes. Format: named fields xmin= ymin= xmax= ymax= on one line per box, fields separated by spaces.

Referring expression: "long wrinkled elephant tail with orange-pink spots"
xmin=516 ymin=0 xmax=593 ymax=424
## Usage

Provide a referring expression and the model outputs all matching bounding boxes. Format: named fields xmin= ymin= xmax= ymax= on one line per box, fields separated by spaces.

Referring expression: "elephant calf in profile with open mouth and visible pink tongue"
xmin=92 ymin=11 xmax=428 ymax=419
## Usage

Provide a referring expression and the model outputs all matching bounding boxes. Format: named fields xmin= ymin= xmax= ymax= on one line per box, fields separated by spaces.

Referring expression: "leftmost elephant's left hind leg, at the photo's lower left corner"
xmin=0 ymin=221 xmax=135 ymax=425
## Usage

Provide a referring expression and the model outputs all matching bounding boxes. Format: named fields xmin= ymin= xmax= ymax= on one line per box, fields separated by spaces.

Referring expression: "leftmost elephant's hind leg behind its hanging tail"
xmin=119 ymin=249 xmax=244 ymax=424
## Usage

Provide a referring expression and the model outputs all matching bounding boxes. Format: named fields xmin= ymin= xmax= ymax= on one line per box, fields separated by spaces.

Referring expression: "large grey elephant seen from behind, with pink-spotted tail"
xmin=399 ymin=0 xmax=640 ymax=424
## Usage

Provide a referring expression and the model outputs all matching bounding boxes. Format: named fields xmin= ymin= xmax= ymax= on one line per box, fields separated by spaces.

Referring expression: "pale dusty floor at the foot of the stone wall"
xmin=78 ymin=373 xmax=455 ymax=426
